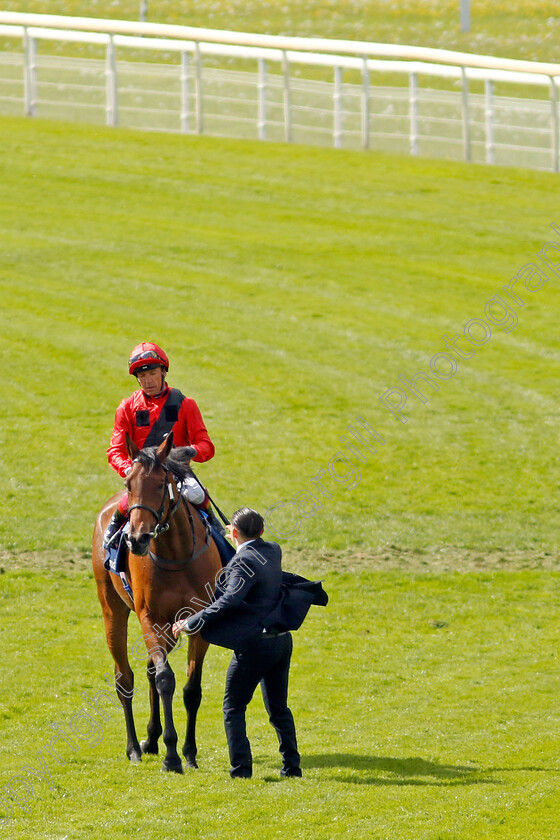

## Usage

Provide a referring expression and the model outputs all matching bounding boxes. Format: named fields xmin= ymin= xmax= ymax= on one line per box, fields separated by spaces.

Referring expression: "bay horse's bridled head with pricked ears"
xmin=126 ymin=433 xmax=177 ymax=556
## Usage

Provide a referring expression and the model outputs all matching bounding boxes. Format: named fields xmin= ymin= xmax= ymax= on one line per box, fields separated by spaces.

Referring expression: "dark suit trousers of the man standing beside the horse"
xmin=224 ymin=633 xmax=300 ymax=777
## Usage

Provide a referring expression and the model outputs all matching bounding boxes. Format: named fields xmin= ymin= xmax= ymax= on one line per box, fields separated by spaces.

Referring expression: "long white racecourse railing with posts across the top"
xmin=0 ymin=12 xmax=560 ymax=172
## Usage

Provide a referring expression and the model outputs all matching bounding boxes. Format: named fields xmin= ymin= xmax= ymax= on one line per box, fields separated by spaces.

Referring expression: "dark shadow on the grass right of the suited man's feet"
xmin=301 ymin=753 xmax=501 ymax=787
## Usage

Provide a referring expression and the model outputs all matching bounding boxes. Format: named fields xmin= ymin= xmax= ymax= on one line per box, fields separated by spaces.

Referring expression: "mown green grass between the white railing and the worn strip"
xmin=0 ymin=113 xmax=560 ymax=552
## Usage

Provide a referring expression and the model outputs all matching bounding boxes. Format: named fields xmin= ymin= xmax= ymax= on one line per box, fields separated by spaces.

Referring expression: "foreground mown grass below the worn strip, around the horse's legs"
xmin=0 ymin=565 xmax=560 ymax=840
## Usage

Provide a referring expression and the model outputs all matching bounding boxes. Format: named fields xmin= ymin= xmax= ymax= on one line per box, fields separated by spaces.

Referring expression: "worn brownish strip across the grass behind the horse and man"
xmin=0 ymin=545 xmax=560 ymax=575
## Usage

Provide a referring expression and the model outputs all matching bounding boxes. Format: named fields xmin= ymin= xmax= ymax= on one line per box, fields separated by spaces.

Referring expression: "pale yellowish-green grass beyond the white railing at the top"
xmin=3 ymin=0 xmax=560 ymax=61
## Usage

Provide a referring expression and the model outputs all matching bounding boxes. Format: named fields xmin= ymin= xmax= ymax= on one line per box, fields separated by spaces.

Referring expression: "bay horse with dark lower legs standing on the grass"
xmin=92 ymin=433 xmax=222 ymax=773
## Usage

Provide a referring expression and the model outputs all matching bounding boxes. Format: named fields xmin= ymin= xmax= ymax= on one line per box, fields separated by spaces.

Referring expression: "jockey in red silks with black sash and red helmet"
xmin=103 ymin=341 xmax=219 ymax=548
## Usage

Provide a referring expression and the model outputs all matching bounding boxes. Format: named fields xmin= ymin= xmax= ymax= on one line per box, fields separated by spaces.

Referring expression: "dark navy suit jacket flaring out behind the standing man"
xmin=189 ymin=538 xmax=328 ymax=649
